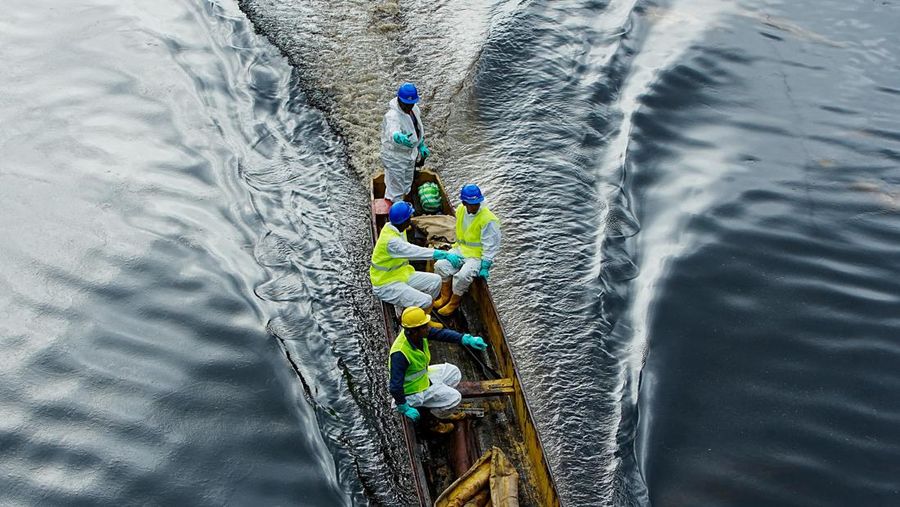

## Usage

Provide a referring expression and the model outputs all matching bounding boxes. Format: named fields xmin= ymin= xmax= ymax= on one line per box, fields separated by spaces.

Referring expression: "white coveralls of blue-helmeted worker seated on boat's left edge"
xmin=372 ymin=224 xmax=441 ymax=309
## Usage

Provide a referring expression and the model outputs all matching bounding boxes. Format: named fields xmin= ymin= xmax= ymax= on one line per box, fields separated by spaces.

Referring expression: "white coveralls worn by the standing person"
xmin=381 ymin=97 xmax=425 ymax=202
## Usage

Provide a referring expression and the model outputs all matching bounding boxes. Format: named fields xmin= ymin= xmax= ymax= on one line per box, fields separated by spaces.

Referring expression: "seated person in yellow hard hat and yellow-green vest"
xmin=388 ymin=306 xmax=487 ymax=426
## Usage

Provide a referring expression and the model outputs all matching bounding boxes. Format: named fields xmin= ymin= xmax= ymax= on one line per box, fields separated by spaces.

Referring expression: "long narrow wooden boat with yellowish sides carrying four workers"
xmin=371 ymin=170 xmax=560 ymax=507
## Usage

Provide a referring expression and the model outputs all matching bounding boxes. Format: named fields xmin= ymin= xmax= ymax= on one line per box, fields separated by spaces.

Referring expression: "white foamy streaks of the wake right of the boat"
xmin=590 ymin=0 xmax=735 ymax=490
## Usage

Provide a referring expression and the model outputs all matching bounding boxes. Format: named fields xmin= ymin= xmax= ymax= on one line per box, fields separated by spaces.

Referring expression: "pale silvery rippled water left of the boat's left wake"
xmin=0 ymin=0 xmax=358 ymax=505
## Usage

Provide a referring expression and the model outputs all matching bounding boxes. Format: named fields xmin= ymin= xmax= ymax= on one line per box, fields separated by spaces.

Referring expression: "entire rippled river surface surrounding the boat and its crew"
xmin=0 ymin=0 xmax=900 ymax=506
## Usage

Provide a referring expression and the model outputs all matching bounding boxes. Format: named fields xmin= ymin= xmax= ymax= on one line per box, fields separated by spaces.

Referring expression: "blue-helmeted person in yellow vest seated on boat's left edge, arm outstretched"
xmin=369 ymin=201 xmax=462 ymax=327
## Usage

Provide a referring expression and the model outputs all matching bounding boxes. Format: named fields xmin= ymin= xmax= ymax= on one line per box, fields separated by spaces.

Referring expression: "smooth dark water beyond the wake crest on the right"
xmin=632 ymin=2 xmax=900 ymax=506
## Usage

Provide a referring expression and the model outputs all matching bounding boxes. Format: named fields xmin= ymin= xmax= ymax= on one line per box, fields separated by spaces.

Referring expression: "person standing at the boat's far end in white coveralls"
xmin=381 ymin=83 xmax=431 ymax=202
